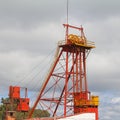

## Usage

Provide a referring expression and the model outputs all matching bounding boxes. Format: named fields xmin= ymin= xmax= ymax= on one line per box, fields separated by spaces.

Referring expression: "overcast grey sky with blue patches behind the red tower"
xmin=0 ymin=0 xmax=120 ymax=120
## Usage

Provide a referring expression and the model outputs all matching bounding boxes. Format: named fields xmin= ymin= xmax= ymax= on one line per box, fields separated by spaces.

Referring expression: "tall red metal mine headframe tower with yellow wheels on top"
xmin=28 ymin=24 xmax=99 ymax=120
